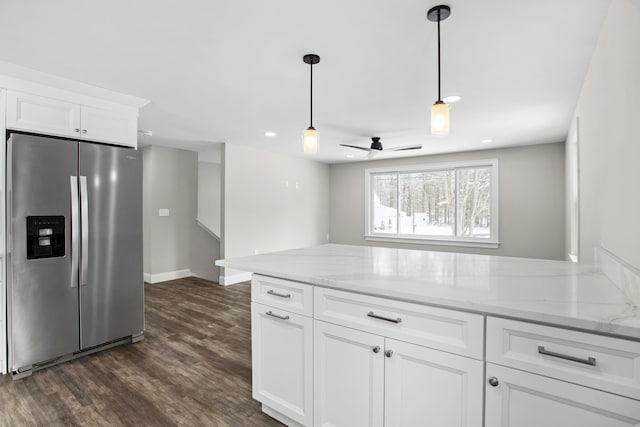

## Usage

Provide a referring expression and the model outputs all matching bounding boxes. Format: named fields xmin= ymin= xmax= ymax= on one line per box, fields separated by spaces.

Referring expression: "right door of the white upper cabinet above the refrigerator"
xmin=81 ymin=105 xmax=138 ymax=147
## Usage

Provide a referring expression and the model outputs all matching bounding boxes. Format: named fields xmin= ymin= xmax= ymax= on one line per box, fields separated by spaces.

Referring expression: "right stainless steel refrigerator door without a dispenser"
xmin=80 ymin=143 xmax=144 ymax=349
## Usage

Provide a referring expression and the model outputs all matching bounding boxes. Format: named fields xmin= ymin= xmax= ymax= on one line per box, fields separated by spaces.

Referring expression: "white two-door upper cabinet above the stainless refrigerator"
xmin=7 ymin=90 xmax=138 ymax=147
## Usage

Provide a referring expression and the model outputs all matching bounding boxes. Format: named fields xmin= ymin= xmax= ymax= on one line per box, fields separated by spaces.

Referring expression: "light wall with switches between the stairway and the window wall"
xmin=220 ymin=144 xmax=329 ymax=284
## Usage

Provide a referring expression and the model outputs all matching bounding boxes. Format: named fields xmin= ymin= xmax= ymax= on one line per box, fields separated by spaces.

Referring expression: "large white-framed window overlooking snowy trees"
xmin=365 ymin=159 xmax=498 ymax=247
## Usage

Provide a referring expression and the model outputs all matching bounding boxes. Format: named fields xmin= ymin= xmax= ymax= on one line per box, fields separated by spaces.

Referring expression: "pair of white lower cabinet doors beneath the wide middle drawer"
xmin=314 ymin=321 xmax=484 ymax=427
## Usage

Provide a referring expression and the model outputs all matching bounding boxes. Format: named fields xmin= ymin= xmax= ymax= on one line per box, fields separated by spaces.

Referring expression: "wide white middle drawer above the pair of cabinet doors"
xmin=314 ymin=287 xmax=484 ymax=360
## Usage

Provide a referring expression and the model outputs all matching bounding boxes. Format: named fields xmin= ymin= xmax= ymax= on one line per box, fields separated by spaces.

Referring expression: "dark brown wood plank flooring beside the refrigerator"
xmin=0 ymin=278 xmax=282 ymax=426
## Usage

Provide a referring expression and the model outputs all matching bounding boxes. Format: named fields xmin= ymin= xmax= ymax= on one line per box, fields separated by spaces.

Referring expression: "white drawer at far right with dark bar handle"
xmin=487 ymin=317 xmax=640 ymax=399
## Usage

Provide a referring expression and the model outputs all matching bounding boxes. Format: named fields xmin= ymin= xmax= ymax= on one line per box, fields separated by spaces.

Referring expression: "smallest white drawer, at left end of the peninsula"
xmin=251 ymin=274 xmax=313 ymax=317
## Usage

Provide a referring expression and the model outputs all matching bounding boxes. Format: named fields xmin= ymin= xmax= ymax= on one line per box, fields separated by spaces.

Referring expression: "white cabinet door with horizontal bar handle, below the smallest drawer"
xmin=251 ymin=303 xmax=313 ymax=426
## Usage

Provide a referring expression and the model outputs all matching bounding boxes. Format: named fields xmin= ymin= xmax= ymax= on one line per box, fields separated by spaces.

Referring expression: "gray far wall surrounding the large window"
xmin=330 ymin=143 xmax=565 ymax=259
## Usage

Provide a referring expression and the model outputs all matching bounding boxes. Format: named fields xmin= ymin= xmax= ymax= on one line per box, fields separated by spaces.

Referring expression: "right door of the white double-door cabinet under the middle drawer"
xmin=385 ymin=338 xmax=484 ymax=427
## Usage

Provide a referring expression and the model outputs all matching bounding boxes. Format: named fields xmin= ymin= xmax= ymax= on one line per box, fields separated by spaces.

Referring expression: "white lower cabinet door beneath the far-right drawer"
xmin=485 ymin=363 xmax=640 ymax=427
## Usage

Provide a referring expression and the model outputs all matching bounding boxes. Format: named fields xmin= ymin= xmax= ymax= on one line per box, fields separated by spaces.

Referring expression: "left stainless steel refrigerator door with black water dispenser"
xmin=7 ymin=134 xmax=79 ymax=371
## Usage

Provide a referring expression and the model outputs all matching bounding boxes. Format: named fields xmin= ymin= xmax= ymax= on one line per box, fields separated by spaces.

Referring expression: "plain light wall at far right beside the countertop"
xmin=575 ymin=0 xmax=640 ymax=268
